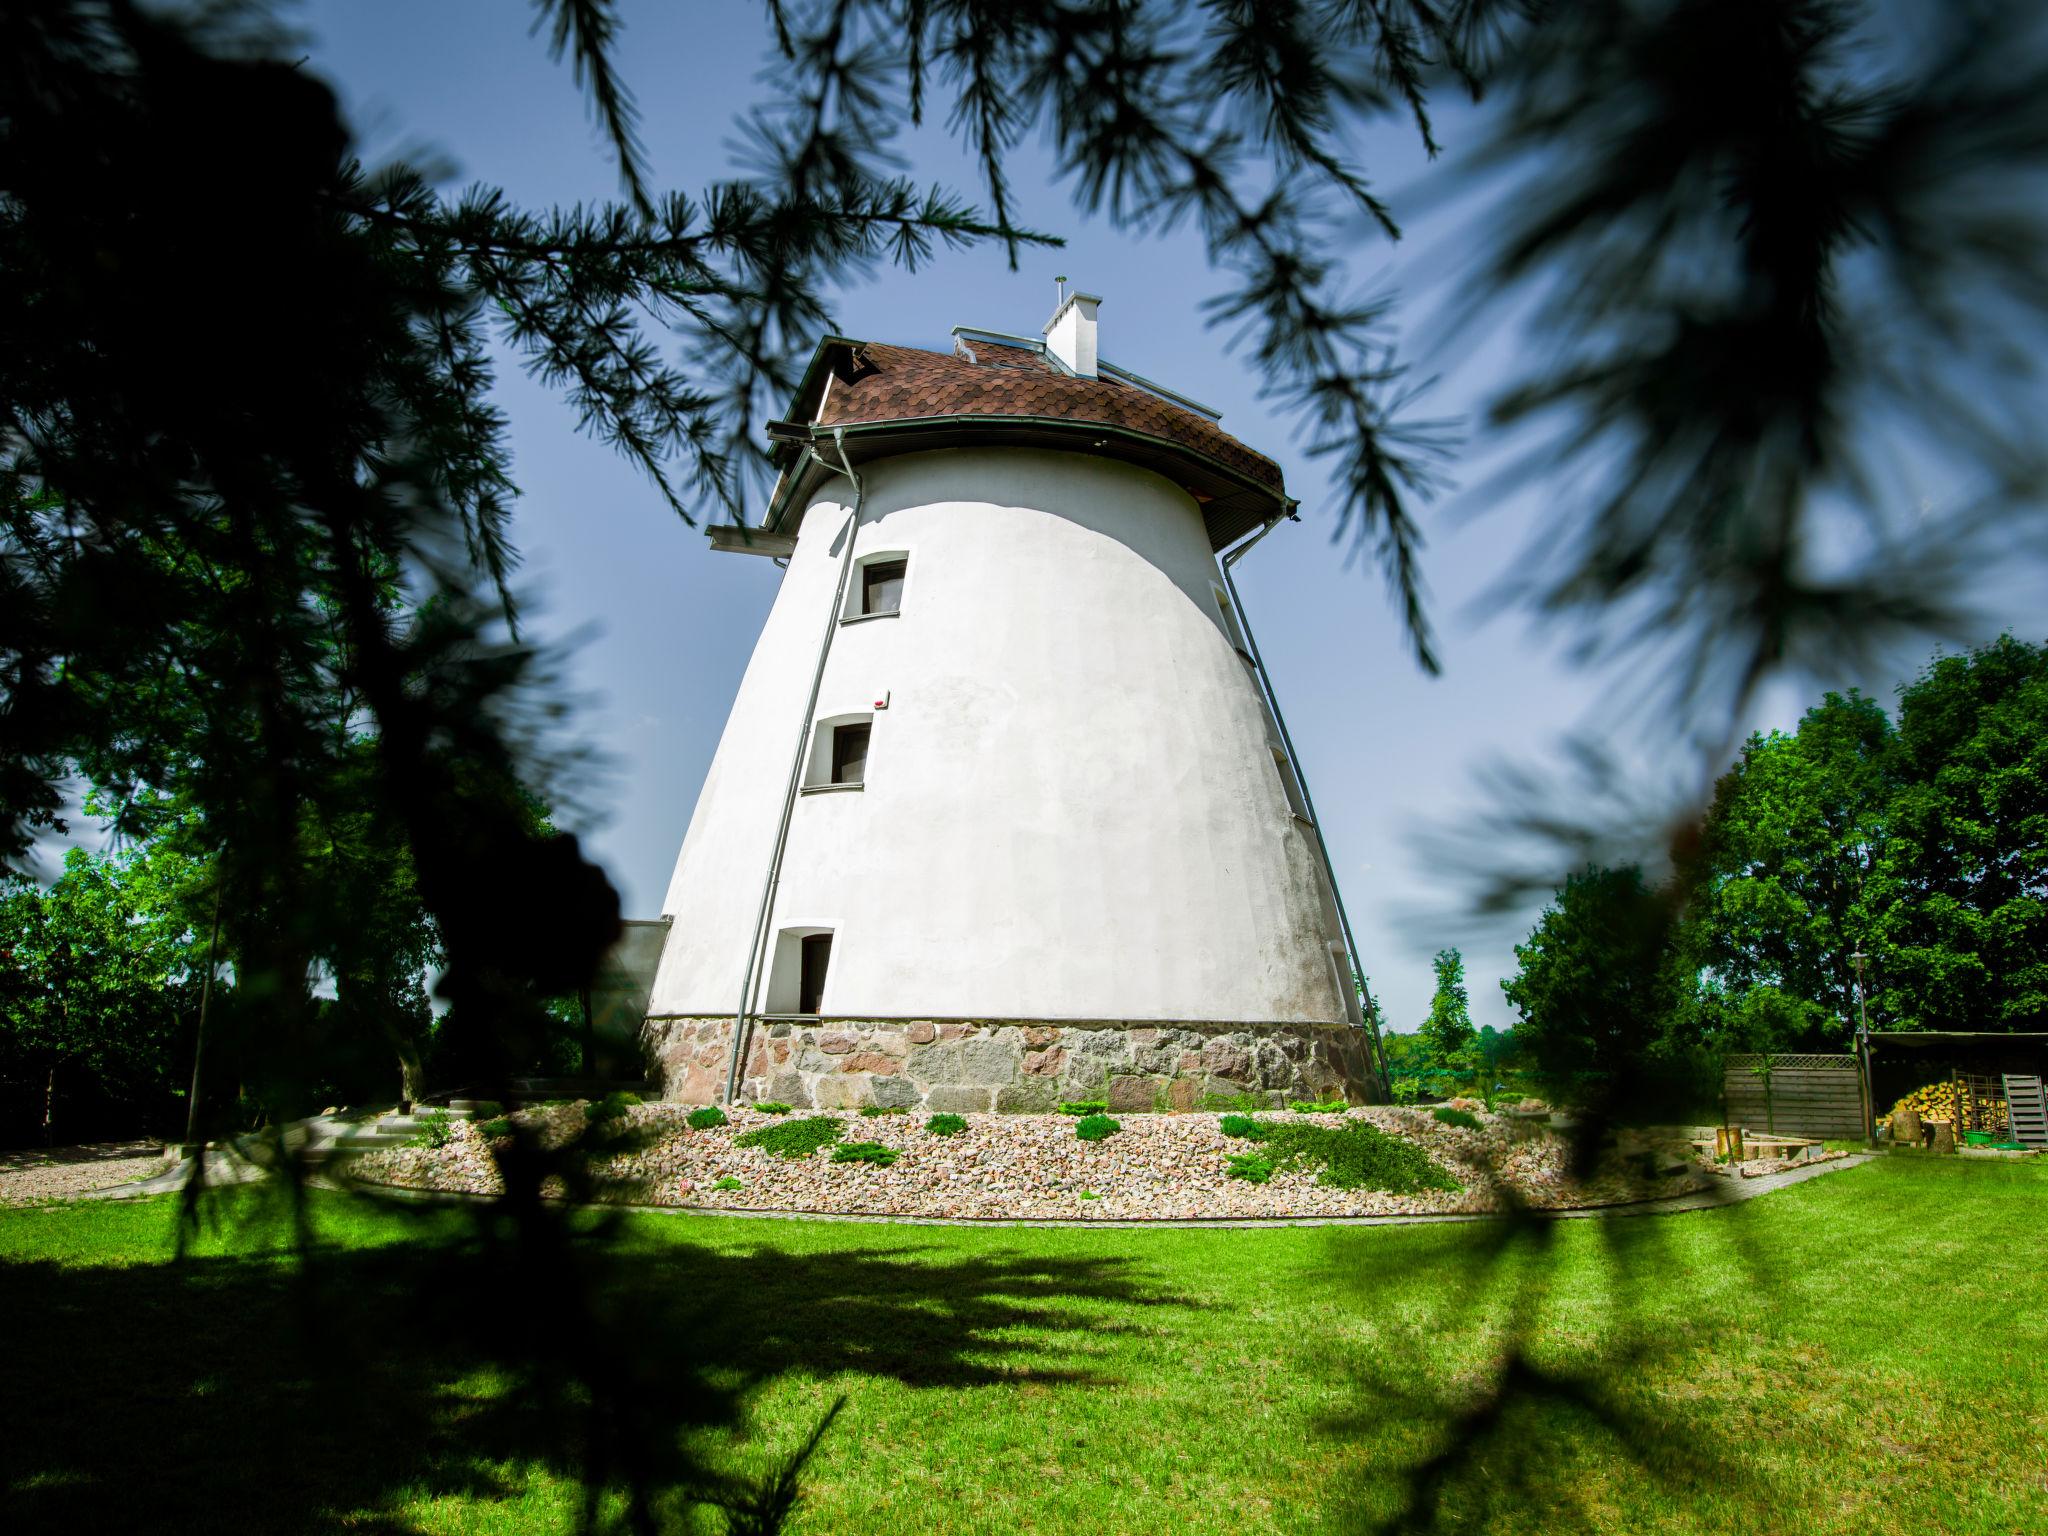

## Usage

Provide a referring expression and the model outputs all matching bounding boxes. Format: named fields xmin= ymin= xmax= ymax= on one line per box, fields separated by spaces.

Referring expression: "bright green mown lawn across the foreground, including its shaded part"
xmin=0 ymin=1159 xmax=2048 ymax=1536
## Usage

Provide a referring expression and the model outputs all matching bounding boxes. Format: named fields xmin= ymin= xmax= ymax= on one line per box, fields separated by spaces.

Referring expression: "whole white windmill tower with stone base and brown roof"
xmin=647 ymin=293 xmax=1374 ymax=1110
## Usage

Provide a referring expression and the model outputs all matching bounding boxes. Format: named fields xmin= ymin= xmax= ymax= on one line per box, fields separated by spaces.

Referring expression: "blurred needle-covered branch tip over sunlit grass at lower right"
xmin=1321 ymin=1146 xmax=1772 ymax=1536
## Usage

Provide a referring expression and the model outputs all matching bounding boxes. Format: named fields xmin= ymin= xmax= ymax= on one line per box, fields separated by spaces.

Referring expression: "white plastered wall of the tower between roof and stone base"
xmin=649 ymin=449 xmax=1346 ymax=1022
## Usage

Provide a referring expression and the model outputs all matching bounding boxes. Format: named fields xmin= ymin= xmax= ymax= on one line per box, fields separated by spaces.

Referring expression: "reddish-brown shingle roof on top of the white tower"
xmin=817 ymin=342 xmax=1286 ymax=496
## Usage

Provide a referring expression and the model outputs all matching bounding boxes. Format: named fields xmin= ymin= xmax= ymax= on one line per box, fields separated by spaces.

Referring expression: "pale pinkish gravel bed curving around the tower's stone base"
xmin=350 ymin=1104 xmax=1706 ymax=1221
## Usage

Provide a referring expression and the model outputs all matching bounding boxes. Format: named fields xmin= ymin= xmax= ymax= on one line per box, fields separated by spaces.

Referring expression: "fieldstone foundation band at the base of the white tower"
xmin=643 ymin=1018 xmax=1372 ymax=1114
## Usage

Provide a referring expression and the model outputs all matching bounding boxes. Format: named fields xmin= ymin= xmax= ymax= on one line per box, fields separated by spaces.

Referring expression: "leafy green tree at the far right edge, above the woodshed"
xmin=1866 ymin=635 xmax=2048 ymax=1030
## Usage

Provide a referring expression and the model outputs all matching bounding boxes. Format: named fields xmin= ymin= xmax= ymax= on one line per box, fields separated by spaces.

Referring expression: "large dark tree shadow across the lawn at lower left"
xmin=0 ymin=1210 xmax=1171 ymax=1532
